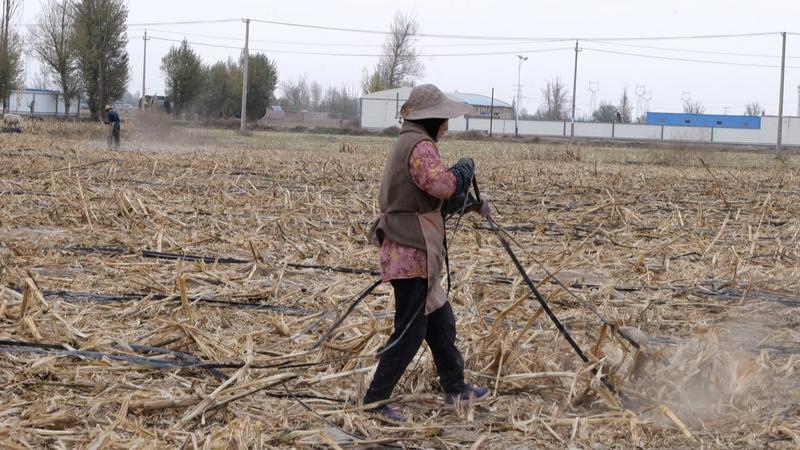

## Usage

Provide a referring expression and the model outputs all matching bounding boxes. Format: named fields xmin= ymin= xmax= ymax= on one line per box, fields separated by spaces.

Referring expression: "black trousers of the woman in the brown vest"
xmin=364 ymin=278 xmax=464 ymax=404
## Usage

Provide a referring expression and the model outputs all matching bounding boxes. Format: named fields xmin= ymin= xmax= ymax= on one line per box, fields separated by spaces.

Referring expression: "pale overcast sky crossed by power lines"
xmin=15 ymin=0 xmax=800 ymax=115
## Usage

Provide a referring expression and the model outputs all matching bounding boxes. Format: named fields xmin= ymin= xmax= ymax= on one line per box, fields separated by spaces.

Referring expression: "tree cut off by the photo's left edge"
xmin=0 ymin=0 xmax=22 ymax=111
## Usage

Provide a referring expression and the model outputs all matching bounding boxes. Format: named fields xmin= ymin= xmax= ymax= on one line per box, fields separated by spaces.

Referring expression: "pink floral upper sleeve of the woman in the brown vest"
xmin=408 ymin=141 xmax=456 ymax=200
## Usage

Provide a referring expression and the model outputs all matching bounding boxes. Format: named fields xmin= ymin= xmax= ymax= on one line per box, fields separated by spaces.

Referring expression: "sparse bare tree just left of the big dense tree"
xmin=31 ymin=0 xmax=80 ymax=114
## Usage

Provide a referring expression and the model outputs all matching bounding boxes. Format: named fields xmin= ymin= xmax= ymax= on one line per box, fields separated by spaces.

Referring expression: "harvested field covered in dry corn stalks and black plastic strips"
xmin=0 ymin=120 xmax=800 ymax=450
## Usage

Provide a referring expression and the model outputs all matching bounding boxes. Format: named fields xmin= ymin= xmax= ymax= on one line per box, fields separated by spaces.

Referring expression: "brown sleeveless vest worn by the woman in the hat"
xmin=370 ymin=122 xmax=442 ymax=251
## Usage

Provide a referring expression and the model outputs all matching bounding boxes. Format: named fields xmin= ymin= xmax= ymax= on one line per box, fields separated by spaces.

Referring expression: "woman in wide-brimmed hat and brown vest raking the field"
xmin=364 ymin=84 xmax=489 ymax=421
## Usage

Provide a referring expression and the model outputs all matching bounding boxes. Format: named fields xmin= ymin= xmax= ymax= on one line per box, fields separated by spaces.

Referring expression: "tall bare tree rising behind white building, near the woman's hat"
xmin=361 ymin=11 xmax=424 ymax=93
